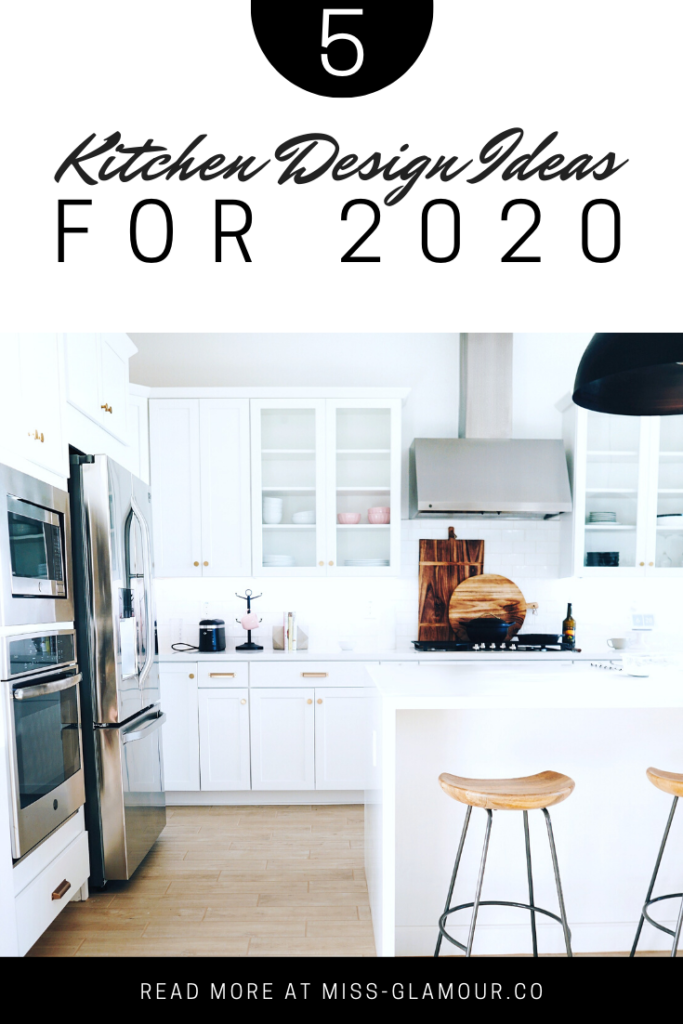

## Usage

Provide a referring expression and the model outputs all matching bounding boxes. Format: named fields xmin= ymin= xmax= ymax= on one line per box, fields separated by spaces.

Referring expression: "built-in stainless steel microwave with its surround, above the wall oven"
xmin=0 ymin=466 xmax=74 ymax=626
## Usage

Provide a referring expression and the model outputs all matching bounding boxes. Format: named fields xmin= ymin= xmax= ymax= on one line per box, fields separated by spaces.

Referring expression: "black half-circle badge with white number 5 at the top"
xmin=252 ymin=0 xmax=434 ymax=96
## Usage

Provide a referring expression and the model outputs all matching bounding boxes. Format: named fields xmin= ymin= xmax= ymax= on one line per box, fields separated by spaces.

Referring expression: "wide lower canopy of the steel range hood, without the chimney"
xmin=410 ymin=437 xmax=571 ymax=519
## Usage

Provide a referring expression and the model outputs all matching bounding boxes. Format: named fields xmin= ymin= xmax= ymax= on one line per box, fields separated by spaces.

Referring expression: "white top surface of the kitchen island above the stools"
xmin=369 ymin=662 xmax=683 ymax=710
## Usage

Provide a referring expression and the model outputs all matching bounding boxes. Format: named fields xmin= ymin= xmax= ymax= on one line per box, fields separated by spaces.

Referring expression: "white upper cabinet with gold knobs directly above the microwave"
xmin=0 ymin=334 xmax=69 ymax=478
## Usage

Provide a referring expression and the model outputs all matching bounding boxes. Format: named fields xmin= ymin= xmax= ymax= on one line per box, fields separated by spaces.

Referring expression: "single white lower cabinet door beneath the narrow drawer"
xmin=199 ymin=687 xmax=251 ymax=791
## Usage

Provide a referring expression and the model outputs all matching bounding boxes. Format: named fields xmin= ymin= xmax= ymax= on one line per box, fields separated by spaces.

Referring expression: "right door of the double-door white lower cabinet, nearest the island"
xmin=315 ymin=688 xmax=373 ymax=790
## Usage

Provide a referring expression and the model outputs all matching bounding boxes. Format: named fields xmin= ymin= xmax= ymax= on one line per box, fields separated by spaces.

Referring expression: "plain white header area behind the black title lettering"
xmin=0 ymin=0 xmax=683 ymax=332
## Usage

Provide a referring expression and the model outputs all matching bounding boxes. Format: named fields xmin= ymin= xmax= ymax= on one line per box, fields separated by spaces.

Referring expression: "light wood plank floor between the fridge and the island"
xmin=28 ymin=806 xmax=375 ymax=956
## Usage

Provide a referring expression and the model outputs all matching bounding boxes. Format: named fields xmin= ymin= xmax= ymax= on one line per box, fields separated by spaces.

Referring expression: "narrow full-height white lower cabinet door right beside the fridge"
xmin=159 ymin=663 xmax=200 ymax=792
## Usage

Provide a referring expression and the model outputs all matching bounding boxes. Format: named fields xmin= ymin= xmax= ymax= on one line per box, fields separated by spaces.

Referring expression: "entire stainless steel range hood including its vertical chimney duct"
xmin=410 ymin=334 xmax=571 ymax=519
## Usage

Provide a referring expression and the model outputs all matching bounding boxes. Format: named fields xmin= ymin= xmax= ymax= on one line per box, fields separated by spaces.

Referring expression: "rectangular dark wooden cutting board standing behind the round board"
xmin=418 ymin=526 xmax=483 ymax=640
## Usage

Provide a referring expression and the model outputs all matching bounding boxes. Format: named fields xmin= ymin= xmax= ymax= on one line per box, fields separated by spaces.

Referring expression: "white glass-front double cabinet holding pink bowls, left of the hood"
xmin=251 ymin=398 xmax=400 ymax=577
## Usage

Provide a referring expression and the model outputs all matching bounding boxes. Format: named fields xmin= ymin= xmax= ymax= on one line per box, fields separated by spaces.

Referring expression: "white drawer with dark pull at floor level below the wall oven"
xmin=15 ymin=833 xmax=90 ymax=956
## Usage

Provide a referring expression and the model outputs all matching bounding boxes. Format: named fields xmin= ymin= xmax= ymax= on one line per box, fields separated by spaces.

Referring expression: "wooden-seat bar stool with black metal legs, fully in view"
xmin=434 ymin=771 xmax=574 ymax=956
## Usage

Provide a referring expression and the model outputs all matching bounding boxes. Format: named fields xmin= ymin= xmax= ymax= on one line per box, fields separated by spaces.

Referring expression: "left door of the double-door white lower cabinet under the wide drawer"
xmin=251 ymin=689 xmax=315 ymax=790
